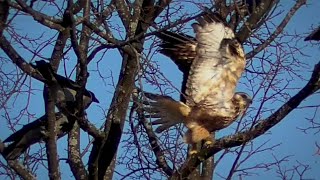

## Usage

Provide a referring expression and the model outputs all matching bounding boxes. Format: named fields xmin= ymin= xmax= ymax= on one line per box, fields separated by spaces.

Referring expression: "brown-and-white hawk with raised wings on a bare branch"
xmin=144 ymin=11 xmax=251 ymax=151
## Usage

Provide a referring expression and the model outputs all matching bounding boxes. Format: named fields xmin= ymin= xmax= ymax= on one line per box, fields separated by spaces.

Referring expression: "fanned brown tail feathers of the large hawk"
xmin=143 ymin=92 xmax=190 ymax=133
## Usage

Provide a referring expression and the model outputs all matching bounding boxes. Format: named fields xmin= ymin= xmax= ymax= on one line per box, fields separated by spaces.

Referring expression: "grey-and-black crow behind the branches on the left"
xmin=2 ymin=60 xmax=99 ymax=159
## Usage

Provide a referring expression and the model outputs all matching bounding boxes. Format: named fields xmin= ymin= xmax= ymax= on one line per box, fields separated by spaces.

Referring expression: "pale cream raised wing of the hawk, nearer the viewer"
xmin=186 ymin=14 xmax=245 ymax=107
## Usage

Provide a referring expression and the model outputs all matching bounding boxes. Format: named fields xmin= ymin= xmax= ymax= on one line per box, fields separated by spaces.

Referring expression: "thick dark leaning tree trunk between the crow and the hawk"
xmin=89 ymin=1 xmax=172 ymax=179
